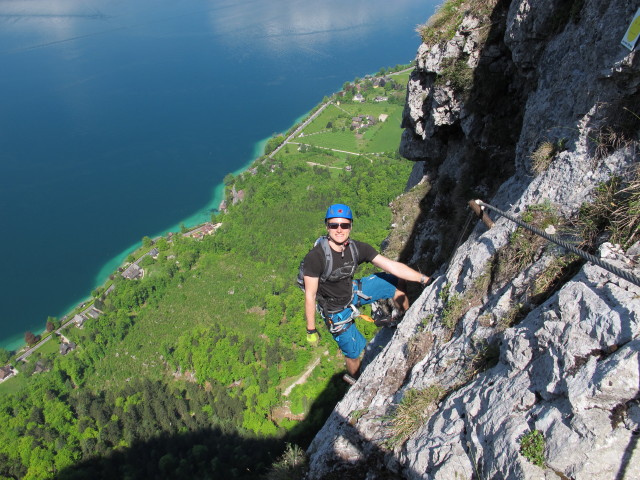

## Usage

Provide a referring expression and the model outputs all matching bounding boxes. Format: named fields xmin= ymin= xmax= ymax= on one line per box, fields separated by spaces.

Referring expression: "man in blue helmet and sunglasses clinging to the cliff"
xmin=302 ymin=204 xmax=429 ymax=378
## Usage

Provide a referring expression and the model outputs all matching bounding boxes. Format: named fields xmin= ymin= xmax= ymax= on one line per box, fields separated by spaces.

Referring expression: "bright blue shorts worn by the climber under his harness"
xmin=333 ymin=272 xmax=398 ymax=358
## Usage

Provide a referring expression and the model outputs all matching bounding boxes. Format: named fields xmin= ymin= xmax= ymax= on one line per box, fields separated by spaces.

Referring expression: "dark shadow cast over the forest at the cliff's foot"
xmin=56 ymin=374 xmax=348 ymax=480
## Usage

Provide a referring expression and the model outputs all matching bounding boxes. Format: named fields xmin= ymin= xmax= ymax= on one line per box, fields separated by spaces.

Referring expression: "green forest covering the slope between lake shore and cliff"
xmin=0 ymin=69 xmax=412 ymax=479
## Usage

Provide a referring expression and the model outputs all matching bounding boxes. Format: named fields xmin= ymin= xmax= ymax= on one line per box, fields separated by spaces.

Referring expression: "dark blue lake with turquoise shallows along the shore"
xmin=0 ymin=0 xmax=436 ymax=348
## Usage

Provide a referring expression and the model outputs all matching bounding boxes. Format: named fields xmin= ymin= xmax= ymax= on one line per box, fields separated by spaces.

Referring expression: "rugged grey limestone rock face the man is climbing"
xmin=307 ymin=0 xmax=640 ymax=479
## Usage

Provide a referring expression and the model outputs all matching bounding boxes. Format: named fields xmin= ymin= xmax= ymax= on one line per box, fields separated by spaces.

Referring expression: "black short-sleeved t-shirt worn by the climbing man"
xmin=304 ymin=240 xmax=378 ymax=311
